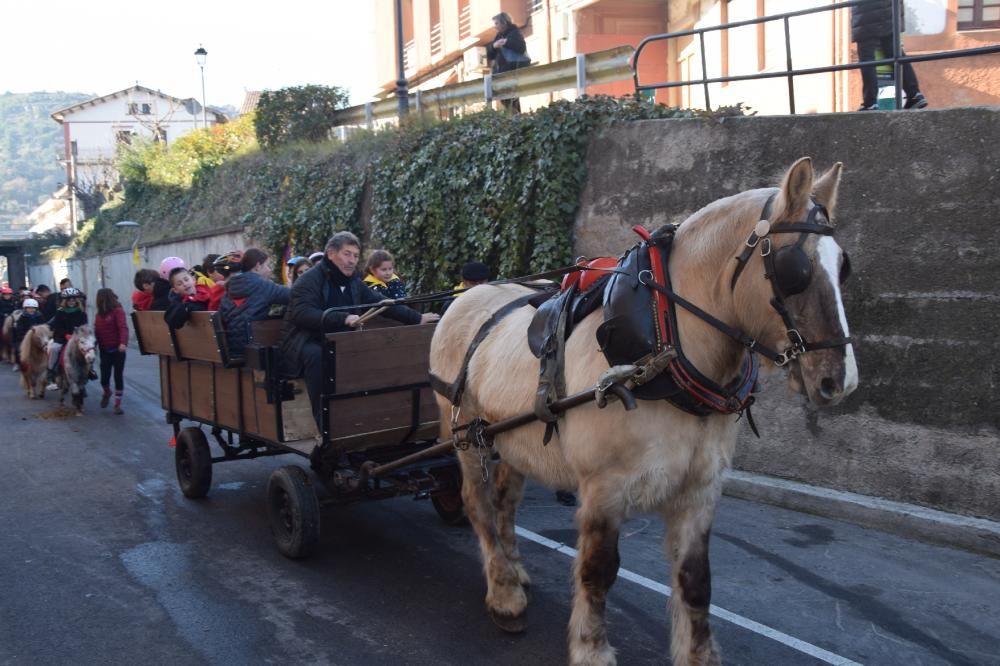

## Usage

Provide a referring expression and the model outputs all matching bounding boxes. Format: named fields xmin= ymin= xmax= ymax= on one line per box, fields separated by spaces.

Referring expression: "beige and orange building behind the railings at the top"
xmin=373 ymin=0 xmax=1000 ymax=113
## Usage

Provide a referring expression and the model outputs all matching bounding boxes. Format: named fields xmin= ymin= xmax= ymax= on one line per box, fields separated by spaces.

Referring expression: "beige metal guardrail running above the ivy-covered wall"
xmin=334 ymin=46 xmax=635 ymax=129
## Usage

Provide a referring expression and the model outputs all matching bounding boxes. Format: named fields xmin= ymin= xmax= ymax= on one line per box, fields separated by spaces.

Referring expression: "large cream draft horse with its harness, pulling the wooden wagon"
xmin=431 ymin=158 xmax=858 ymax=666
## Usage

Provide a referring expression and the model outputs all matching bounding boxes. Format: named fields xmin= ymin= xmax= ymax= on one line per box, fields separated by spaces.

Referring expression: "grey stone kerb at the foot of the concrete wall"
xmin=723 ymin=470 xmax=1000 ymax=557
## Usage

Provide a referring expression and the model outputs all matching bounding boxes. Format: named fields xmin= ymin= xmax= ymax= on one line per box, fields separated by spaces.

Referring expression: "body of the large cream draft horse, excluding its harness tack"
xmin=430 ymin=158 xmax=858 ymax=666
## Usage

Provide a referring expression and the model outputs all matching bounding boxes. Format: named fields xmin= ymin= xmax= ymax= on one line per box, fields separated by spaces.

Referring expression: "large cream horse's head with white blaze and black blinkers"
xmin=730 ymin=157 xmax=858 ymax=405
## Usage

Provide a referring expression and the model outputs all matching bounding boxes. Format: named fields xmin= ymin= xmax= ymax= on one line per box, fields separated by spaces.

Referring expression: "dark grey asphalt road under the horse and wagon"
xmin=0 ymin=350 xmax=1000 ymax=666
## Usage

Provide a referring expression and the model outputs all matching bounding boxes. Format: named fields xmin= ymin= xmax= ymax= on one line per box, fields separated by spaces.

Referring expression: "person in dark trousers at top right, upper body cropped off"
xmin=851 ymin=0 xmax=927 ymax=111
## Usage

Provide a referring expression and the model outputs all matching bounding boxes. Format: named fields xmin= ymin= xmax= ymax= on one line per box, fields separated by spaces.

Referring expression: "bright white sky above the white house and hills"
xmin=0 ymin=0 xmax=375 ymax=108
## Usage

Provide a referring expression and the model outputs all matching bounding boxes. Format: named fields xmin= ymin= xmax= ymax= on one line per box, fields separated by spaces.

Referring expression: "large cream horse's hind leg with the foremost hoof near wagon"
xmin=458 ymin=450 xmax=528 ymax=633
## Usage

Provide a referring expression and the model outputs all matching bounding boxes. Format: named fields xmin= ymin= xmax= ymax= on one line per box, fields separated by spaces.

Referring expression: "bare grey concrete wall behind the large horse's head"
xmin=575 ymin=108 xmax=1000 ymax=519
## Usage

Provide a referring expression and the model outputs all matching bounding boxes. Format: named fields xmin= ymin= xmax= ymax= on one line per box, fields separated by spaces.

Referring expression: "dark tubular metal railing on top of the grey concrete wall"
xmin=632 ymin=0 xmax=1000 ymax=114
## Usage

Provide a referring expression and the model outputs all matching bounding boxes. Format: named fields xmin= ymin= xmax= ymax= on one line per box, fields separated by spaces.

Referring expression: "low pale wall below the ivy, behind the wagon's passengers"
xmin=28 ymin=231 xmax=250 ymax=326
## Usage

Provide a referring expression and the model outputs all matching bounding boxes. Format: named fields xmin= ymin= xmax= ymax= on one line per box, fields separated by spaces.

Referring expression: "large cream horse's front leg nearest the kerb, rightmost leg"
xmin=665 ymin=483 xmax=722 ymax=666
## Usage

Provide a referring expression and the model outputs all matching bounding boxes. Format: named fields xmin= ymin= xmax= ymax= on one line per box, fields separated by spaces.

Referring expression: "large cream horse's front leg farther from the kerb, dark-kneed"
xmin=569 ymin=483 xmax=624 ymax=666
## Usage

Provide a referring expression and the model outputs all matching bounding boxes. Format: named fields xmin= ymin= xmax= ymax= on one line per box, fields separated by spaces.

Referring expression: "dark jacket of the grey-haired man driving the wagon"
xmin=281 ymin=257 xmax=420 ymax=377
